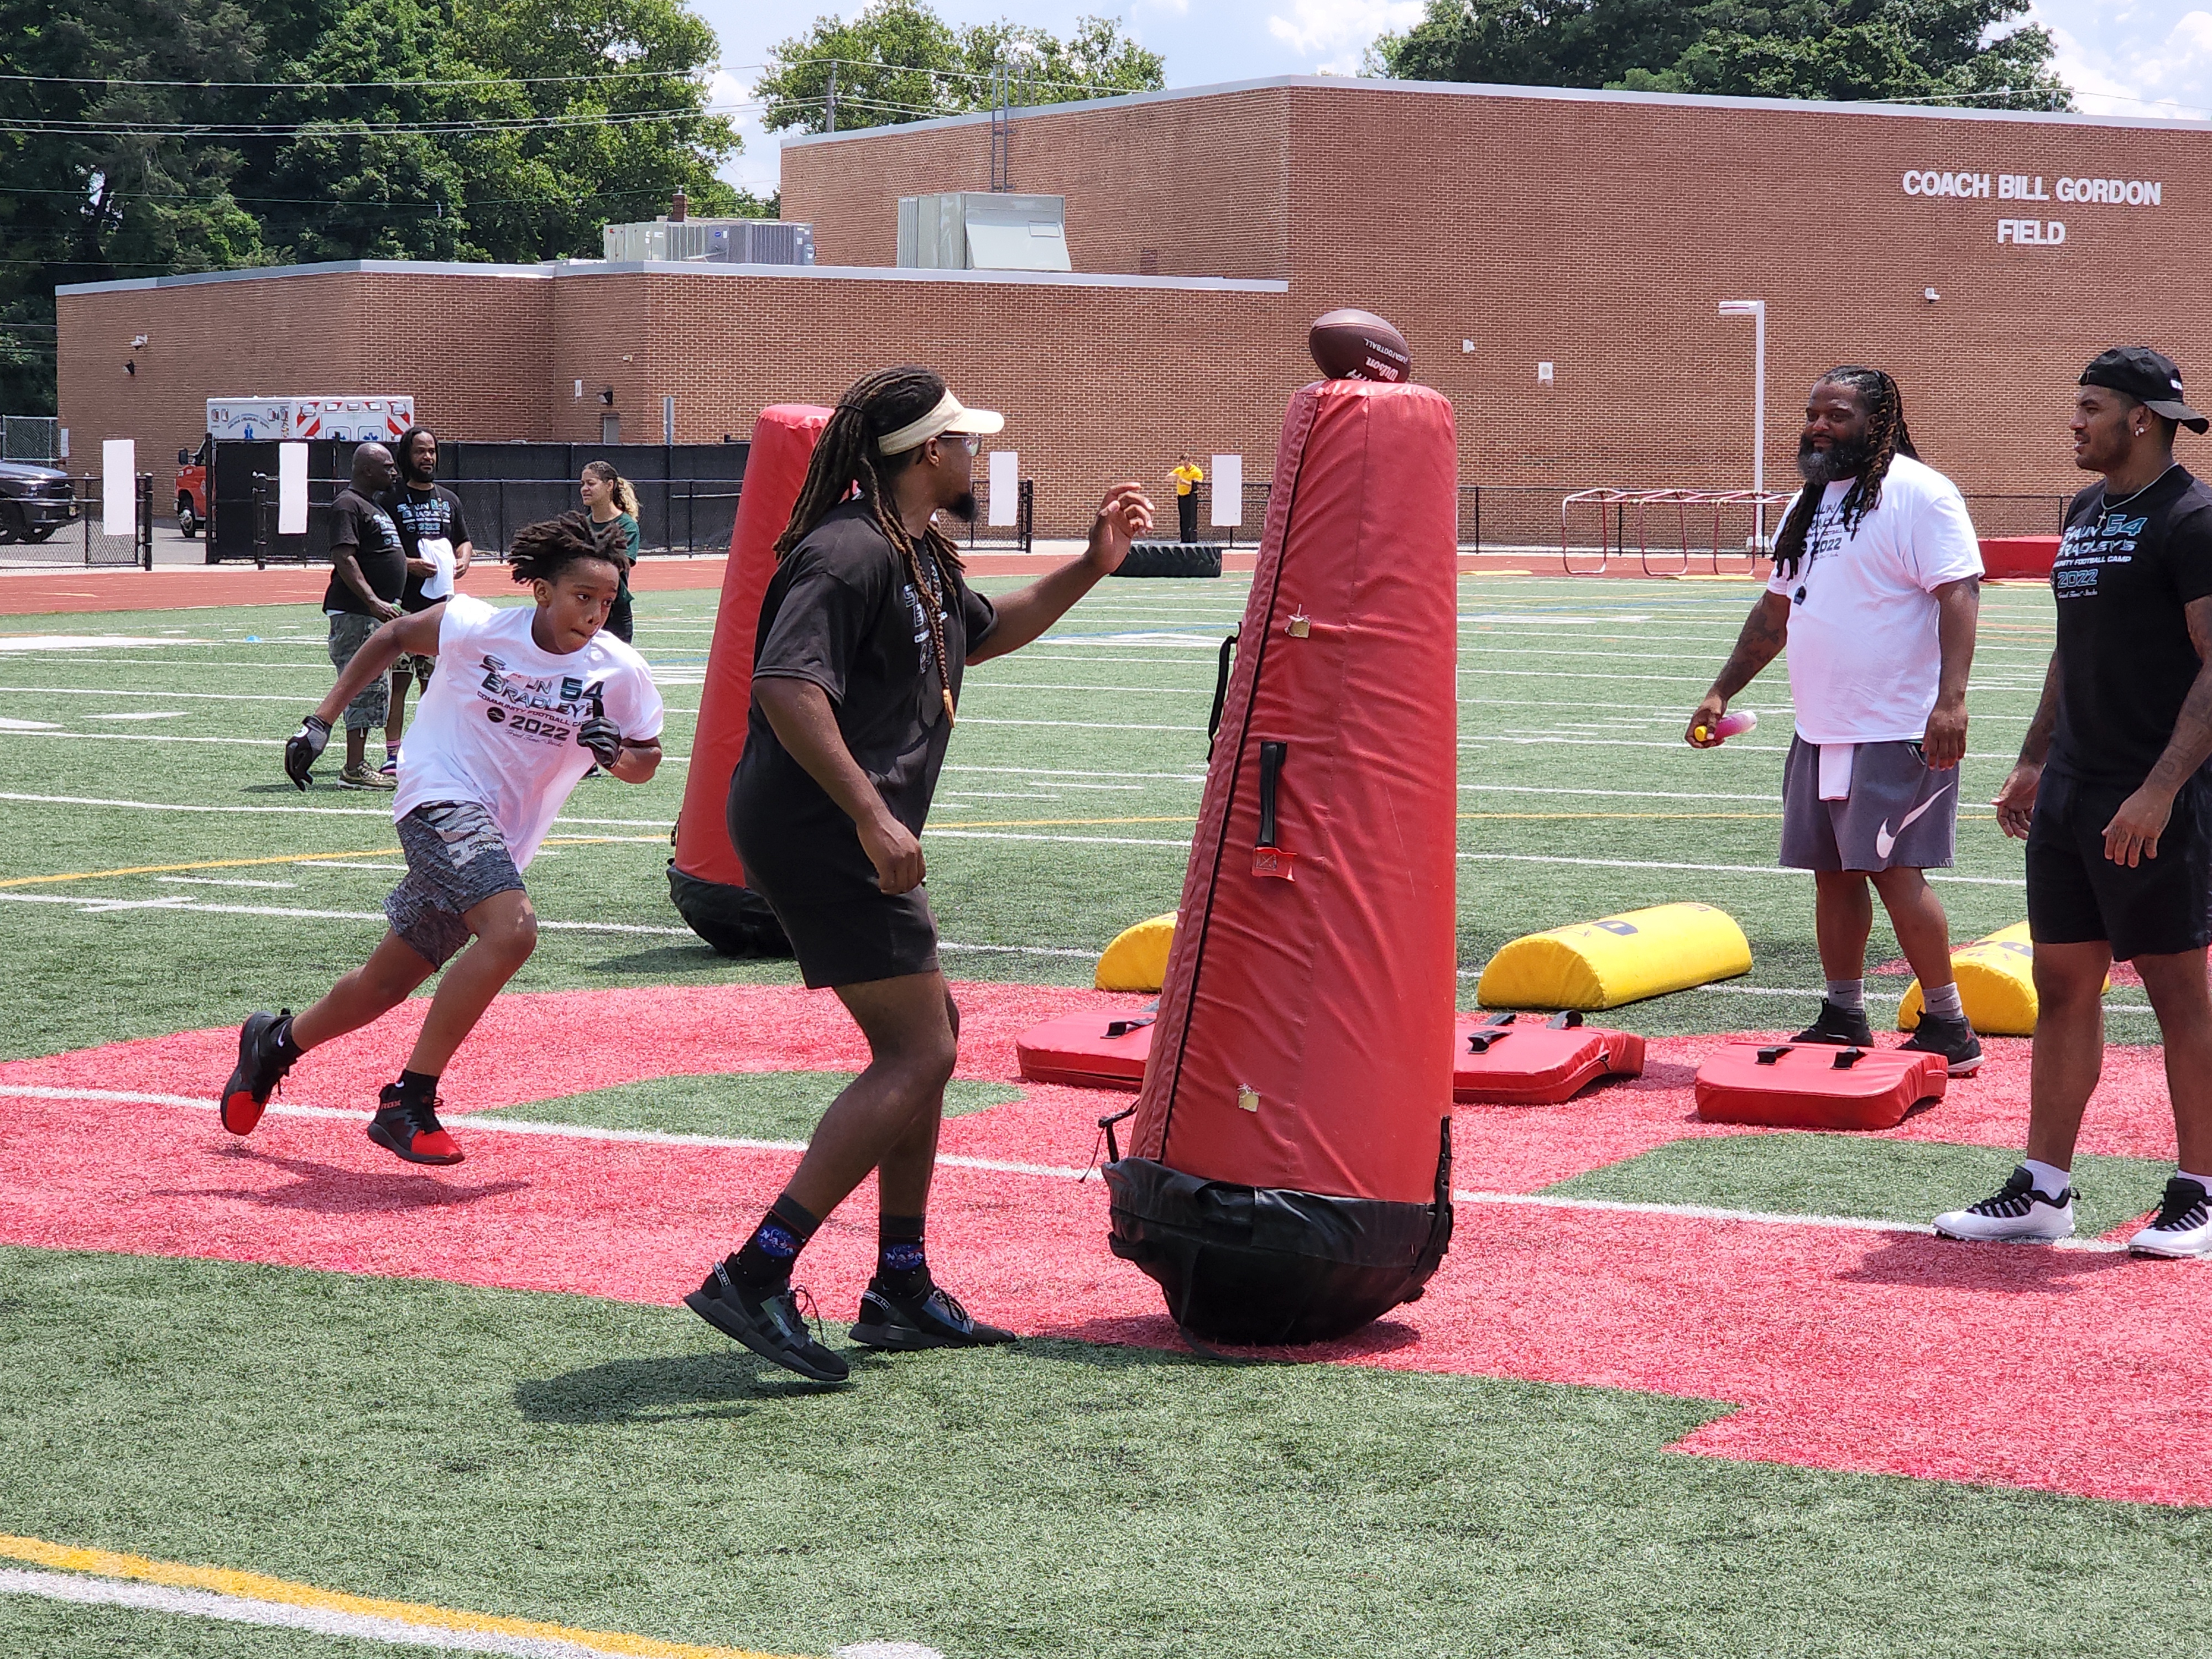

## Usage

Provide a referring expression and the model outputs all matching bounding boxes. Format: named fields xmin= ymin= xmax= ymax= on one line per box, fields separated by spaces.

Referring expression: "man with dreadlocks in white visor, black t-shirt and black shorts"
xmin=684 ymin=367 xmax=1152 ymax=1383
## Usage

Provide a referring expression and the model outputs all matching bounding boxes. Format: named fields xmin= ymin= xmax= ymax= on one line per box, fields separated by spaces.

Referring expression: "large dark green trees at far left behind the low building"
xmin=0 ymin=0 xmax=743 ymax=411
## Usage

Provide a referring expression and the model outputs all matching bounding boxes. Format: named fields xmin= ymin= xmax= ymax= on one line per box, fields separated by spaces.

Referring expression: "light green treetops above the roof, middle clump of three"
xmin=754 ymin=0 xmax=1166 ymax=133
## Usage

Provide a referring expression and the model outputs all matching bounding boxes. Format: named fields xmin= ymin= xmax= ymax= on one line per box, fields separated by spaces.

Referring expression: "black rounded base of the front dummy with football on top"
xmin=1106 ymin=1121 xmax=1451 ymax=1347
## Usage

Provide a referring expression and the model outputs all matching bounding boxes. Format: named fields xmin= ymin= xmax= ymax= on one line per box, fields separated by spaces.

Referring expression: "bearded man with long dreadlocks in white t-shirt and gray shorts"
xmin=1686 ymin=367 xmax=1982 ymax=1077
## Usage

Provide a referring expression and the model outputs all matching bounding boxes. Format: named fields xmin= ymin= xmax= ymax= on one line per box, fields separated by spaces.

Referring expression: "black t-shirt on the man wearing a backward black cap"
xmin=2051 ymin=467 xmax=2212 ymax=787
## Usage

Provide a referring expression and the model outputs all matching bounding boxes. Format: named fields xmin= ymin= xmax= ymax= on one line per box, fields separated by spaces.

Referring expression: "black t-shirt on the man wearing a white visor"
xmin=730 ymin=502 xmax=998 ymax=902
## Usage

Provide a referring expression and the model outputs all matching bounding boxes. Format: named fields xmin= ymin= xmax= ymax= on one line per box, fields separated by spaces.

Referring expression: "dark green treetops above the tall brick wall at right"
xmin=1371 ymin=0 xmax=2073 ymax=111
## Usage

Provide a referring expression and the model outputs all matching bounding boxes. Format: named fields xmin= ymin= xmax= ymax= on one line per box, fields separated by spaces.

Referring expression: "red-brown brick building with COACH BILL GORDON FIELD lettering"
xmin=60 ymin=77 xmax=2212 ymax=529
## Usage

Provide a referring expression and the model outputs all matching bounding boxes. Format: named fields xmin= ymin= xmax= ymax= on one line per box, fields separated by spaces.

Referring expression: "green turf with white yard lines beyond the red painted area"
xmin=0 ymin=577 xmax=2079 ymax=1055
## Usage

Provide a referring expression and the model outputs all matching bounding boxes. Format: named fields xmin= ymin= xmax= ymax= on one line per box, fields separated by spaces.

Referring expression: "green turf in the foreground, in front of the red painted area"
xmin=0 ymin=1250 xmax=2212 ymax=1659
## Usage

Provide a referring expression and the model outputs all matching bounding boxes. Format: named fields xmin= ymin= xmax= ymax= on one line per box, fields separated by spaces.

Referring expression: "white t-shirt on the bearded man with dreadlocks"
xmin=1767 ymin=456 xmax=1982 ymax=743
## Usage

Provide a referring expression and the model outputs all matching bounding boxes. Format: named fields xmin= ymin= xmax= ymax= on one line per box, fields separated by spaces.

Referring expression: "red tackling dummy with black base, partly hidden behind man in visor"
xmin=668 ymin=403 xmax=830 ymax=956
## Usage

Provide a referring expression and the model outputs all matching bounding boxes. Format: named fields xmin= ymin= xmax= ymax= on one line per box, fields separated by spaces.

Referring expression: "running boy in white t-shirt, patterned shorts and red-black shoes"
xmin=219 ymin=513 xmax=661 ymax=1164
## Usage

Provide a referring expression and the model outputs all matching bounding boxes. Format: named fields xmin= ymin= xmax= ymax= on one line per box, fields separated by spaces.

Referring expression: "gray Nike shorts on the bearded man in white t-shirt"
xmin=1781 ymin=737 xmax=1958 ymax=872
